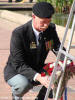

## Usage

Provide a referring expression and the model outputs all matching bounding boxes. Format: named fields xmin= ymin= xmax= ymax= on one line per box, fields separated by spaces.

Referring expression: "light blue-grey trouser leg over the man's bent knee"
xmin=7 ymin=74 xmax=33 ymax=100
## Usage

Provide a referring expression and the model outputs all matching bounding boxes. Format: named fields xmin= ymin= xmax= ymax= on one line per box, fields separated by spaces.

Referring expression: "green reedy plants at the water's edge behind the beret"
xmin=37 ymin=0 xmax=73 ymax=13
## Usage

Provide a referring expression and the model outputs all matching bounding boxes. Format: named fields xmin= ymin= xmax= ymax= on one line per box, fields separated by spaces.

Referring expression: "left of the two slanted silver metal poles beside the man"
xmin=44 ymin=1 xmax=75 ymax=100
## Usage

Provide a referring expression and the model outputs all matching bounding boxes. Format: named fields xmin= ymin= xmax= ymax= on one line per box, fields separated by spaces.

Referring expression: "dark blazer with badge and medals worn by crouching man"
xmin=4 ymin=21 xmax=60 ymax=81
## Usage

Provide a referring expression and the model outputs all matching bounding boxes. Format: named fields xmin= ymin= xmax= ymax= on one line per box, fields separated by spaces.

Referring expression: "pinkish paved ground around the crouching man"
xmin=0 ymin=11 xmax=75 ymax=100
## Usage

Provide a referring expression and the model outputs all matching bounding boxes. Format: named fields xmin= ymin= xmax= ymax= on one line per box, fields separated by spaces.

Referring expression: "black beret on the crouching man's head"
xmin=32 ymin=2 xmax=54 ymax=18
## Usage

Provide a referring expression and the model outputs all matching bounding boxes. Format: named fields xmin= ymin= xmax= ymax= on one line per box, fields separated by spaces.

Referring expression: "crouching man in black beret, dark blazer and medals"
xmin=4 ymin=2 xmax=63 ymax=100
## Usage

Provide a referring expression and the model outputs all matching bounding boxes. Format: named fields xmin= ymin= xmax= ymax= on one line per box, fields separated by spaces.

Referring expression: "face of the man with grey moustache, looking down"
xmin=32 ymin=14 xmax=51 ymax=31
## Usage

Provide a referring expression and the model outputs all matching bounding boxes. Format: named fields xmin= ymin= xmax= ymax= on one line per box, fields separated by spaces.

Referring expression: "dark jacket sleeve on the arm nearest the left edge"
xmin=10 ymin=30 xmax=36 ymax=79
